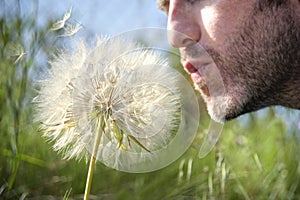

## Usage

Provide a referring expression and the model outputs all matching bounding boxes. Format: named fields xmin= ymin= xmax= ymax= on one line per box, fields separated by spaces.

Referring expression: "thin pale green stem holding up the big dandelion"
xmin=84 ymin=117 xmax=102 ymax=200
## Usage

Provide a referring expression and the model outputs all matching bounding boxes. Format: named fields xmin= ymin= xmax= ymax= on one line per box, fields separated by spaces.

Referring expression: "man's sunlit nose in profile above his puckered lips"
xmin=168 ymin=0 xmax=201 ymax=48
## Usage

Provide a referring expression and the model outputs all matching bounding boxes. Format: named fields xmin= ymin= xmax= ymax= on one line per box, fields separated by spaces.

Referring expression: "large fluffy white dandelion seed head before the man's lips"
xmin=34 ymin=38 xmax=179 ymax=162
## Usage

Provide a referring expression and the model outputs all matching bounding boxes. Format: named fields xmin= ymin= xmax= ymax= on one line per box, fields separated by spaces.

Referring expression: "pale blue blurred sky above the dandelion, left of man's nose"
xmin=13 ymin=0 xmax=171 ymax=77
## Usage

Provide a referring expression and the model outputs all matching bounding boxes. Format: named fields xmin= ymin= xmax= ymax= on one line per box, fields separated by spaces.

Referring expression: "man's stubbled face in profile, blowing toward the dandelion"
xmin=158 ymin=0 xmax=300 ymax=121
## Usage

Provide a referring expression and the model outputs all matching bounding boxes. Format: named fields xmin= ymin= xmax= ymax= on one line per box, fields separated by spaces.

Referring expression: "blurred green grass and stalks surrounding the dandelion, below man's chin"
xmin=0 ymin=1 xmax=300 ymax=200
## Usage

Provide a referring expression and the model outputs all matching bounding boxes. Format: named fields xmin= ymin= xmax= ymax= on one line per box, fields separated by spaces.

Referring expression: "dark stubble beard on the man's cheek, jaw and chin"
xmin=196 ymin=2 xmax=300 ymax=121
